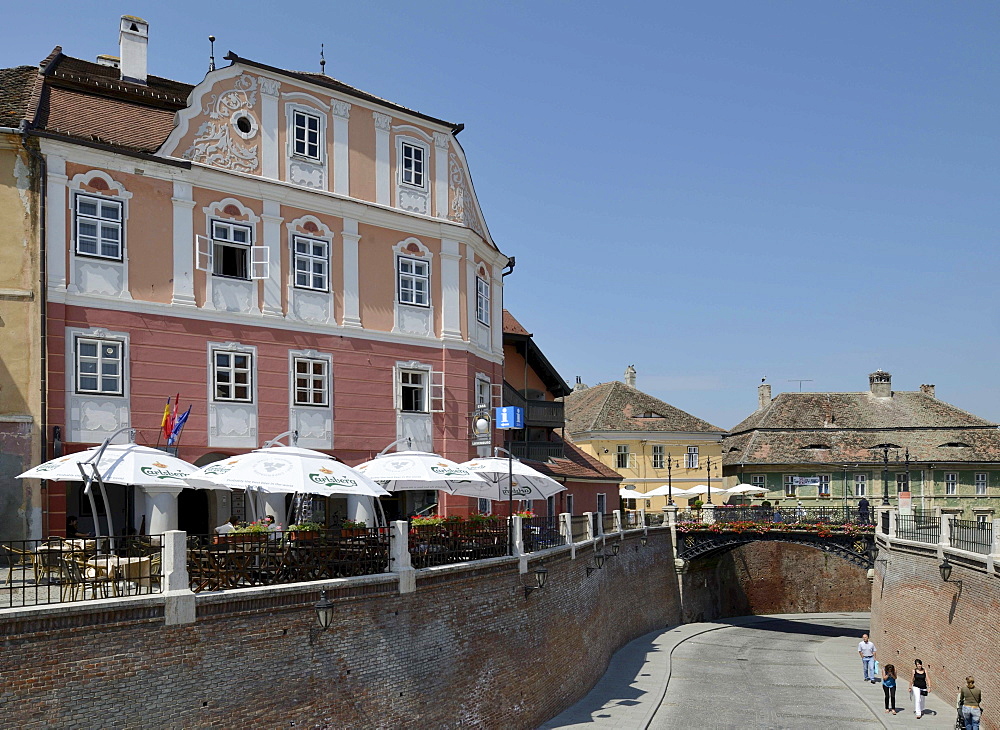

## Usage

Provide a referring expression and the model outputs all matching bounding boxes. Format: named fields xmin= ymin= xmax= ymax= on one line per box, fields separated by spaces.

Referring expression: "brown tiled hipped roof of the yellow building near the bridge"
xmin=563 ymin=381 xmax=725 ymax=434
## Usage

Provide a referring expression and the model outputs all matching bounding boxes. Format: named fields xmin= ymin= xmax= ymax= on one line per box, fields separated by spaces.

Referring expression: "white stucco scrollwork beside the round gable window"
xmin=181 ymin=74 xmax=260 ymax=172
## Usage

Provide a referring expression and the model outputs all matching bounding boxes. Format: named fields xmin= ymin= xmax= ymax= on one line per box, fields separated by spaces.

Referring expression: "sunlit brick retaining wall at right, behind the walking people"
xmin=871 ymin=543 xmax=1000 ymax=730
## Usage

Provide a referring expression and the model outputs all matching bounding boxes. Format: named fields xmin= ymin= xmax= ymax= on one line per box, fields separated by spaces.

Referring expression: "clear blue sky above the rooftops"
xmin=0 ymin=0 xmax=1000 ymax=428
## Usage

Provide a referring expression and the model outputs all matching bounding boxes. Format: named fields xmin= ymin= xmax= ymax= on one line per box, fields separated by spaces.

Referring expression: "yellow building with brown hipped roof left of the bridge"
xmin=564 ymin=366 xmax=725 ymax=511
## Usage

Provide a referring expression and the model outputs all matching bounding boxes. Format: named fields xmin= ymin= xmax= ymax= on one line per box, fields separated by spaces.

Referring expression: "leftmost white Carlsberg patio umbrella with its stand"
xmin=18 ymin=438 xmax=207 ymax=535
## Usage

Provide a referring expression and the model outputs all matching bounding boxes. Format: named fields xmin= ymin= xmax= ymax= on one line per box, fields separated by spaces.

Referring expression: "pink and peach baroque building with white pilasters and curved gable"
xmin=0 ymin=16 xmax=508 ymax=536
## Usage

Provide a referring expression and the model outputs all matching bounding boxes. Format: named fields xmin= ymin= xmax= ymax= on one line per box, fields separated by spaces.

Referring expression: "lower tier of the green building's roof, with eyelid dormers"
xmin=722 ymin=426 xmax=1000 ymax=471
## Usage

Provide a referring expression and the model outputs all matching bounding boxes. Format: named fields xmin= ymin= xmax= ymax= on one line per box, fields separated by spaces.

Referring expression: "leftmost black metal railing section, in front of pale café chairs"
xmin=0 ymin=535 xmax=163 ymax=608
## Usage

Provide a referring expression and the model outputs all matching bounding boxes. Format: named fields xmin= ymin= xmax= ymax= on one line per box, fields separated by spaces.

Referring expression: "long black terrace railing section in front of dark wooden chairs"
xmin=187 ymin=527 xmax=389 ymax=592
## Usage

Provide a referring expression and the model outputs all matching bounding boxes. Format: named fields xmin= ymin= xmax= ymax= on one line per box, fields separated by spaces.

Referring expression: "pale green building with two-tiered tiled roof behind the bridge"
xmin=723 ymin=370 xmax=1000 ymax=520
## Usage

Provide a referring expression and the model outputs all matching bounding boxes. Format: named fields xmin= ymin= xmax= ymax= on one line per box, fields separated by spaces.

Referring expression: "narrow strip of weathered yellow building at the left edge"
xmin=0 ymin=86 xmax=45 ymax=542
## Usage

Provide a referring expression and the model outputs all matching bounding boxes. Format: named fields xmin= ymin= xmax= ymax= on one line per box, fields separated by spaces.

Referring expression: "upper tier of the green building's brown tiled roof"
xmin=730 ymin=391 xmax=997 ymax=434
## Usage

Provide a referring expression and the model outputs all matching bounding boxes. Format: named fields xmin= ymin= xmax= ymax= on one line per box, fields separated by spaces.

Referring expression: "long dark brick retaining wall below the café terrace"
xmin=0 ymin=529 xmax=680 ymax=730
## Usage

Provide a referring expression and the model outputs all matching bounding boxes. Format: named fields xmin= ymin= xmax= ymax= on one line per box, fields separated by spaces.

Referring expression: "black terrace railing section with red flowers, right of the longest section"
xmin=408 ymin=518 xmax=510 ymax=568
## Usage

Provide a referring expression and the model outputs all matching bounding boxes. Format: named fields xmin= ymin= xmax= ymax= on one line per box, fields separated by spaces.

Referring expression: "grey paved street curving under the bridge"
xmin=542 ymin=613 xmax=955 ymax=730
